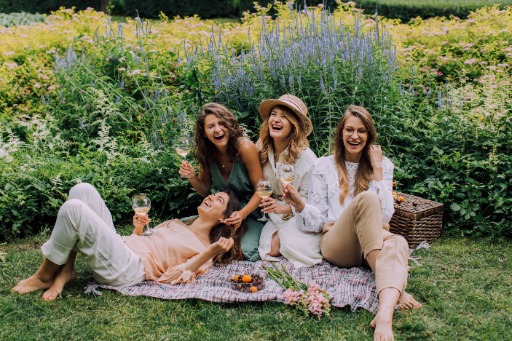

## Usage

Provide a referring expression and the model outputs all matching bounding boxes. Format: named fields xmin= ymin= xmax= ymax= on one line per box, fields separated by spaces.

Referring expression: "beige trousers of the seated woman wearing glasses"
xmin=320 ymin=191 xmax=409 ymax=294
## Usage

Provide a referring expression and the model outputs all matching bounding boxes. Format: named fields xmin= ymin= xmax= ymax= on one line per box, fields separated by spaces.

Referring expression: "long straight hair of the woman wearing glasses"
xmin=334 ymin=105 xmax=377 ymax=203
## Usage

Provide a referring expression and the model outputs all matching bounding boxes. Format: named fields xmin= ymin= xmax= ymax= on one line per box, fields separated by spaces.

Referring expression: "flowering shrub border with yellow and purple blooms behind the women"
xmin=0 ymin=4 xmax=512 ymax=239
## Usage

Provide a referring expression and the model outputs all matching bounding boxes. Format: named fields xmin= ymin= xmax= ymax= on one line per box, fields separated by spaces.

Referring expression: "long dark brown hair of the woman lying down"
xmin=210 ymin=190 xmax=245 ymax=264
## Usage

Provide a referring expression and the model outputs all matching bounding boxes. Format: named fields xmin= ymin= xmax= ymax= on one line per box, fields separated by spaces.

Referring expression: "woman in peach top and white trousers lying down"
xmin=12 ymin=183 xmax=241 ymax=300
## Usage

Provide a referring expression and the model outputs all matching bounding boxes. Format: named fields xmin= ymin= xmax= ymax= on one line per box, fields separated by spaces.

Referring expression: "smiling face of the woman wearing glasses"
xmin=343 ymin=115 xmax=368 ymax=162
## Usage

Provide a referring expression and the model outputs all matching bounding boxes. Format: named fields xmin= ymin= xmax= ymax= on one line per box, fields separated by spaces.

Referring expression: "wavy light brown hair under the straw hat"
xmin=256 ymin=105 xmax=309 ymax=165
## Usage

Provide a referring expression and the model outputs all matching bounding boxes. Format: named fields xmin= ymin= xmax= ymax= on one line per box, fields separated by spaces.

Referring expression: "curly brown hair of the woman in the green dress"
xmin=195 ymin=103 xmax=243 ymax=169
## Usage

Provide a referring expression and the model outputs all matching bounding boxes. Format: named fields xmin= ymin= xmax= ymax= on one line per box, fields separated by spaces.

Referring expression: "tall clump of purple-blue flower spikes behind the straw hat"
xmin=194 ymin=7 xmax=396 ymax=155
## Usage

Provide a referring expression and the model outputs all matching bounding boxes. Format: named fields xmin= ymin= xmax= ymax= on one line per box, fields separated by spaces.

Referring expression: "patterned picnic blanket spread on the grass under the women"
xmin=85 ymin=257 xmax=378 ymax=313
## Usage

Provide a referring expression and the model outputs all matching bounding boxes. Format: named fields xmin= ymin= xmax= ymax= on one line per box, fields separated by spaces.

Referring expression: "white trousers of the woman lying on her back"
xmin=41 ymin=183 xmax=145 ymax=287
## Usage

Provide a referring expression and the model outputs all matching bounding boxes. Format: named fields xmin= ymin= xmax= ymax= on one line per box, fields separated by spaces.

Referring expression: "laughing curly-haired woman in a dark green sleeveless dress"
xmin=179 ymin=103 xmax=263 ymax=261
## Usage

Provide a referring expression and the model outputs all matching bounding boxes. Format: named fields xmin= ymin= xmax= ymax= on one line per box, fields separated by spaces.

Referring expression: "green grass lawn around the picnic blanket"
xmin=0 ymin=237 xmax=512 ymax=340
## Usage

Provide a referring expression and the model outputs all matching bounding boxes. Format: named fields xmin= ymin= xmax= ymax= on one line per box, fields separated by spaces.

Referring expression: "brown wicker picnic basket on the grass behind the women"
xmin=389 ymin=193 xmax=443 ymax=247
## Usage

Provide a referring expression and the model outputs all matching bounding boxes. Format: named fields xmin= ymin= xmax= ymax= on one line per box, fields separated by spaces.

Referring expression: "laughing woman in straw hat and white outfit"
xmin=256 ymin=94 xmax=322 ymax=267
